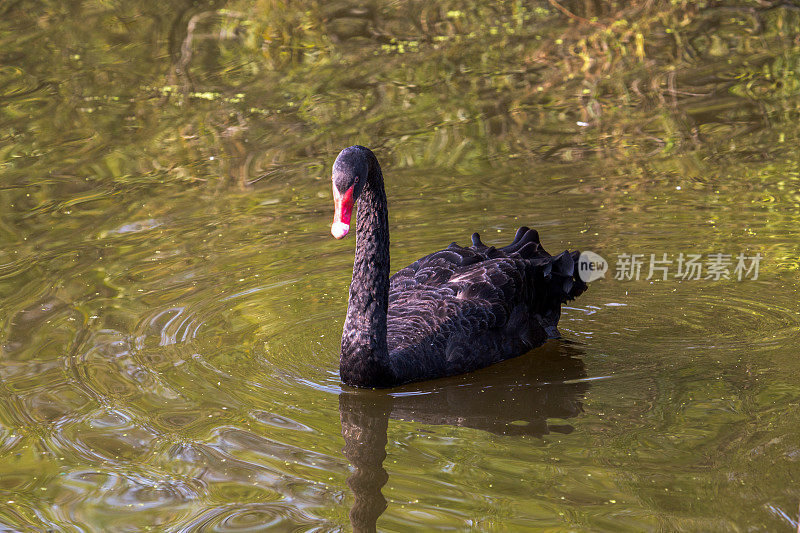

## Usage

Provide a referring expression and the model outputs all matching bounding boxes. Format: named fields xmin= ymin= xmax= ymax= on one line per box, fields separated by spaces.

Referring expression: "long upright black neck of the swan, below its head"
xmin=339 ymin=150 xmax=393 ymax=387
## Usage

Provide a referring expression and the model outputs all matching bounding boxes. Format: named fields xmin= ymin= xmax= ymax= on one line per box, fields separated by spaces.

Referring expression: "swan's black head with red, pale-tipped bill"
xmin=331 ymin=146 xmax=369 ymax=239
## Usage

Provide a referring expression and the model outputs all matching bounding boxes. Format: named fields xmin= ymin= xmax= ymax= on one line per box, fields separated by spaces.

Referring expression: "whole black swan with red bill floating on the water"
xmin=331 ymin=146 xmax=586 ymax=388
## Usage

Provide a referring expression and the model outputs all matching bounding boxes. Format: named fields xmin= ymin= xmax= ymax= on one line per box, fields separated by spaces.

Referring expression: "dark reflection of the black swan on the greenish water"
xmin=339 ymin=343 xmax=589 ymax=531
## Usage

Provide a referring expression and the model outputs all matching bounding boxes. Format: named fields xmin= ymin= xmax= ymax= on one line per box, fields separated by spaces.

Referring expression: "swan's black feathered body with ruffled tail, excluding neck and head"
xmin=387 ymin=228 xmax=586 ymax=381
